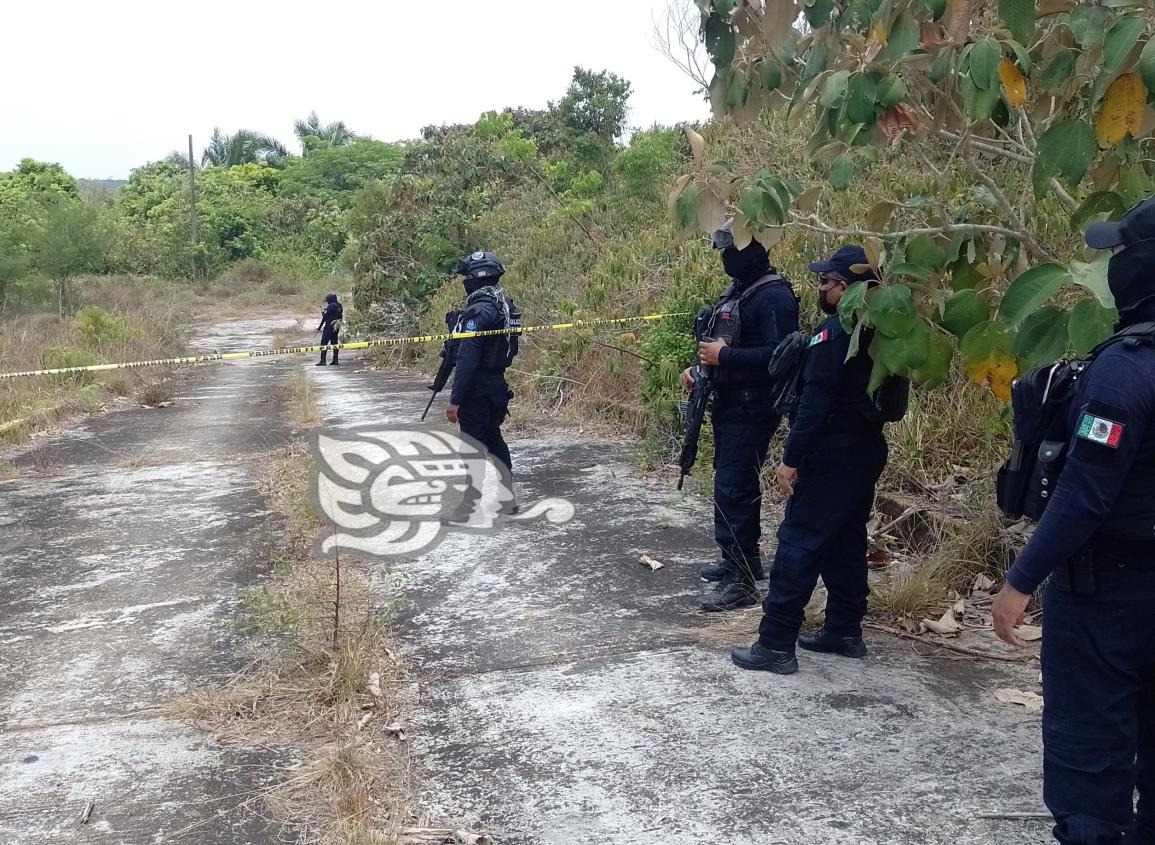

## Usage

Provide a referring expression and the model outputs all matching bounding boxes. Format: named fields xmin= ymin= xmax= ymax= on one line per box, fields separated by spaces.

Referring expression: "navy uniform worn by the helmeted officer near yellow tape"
xmin=450 ymin=289 xmax=513 ymax=470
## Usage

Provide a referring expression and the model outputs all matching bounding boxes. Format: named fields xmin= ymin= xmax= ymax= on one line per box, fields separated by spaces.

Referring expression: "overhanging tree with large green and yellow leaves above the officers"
xmin=671 ymin=0 xmax=1155 ymax=397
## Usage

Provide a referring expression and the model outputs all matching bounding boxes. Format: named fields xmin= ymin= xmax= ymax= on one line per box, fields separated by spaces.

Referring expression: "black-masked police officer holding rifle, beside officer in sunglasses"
xmin=681 ymin=222 xmax=798 ymax=611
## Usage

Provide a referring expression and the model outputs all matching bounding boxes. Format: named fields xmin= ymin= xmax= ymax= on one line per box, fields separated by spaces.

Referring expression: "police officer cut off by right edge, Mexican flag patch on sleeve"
xmin=993 ymin=197 xmax=1155 ymax=845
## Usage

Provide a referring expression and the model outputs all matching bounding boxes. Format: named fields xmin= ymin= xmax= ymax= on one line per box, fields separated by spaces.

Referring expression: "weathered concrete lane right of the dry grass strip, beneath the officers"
xmin=315 ymin=361 xmax=1049 ymax=845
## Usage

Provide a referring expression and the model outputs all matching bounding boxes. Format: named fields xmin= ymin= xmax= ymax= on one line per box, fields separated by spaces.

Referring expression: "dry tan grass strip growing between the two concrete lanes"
xmin=170 ymin=431 xmax=423 ymax=845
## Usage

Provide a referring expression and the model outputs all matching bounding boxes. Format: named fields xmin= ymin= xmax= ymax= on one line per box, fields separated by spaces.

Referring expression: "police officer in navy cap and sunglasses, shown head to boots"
xmin=731 ymin=246 xmax=887 ymax=674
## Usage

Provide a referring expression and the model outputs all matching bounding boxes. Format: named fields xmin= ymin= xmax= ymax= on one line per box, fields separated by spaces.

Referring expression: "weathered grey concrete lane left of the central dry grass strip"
xmin=0 ymin=320 xmax=296 ymax=845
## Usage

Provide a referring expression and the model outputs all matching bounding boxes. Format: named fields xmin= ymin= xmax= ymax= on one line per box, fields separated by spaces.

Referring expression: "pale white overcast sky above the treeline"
xmin=0 ymin=0 xmax=708 ymax=178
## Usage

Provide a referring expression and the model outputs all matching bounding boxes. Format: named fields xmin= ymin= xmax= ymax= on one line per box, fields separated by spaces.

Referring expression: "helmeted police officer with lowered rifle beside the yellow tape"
xmin=446 ymin=252 xmax=521 ymax=482
